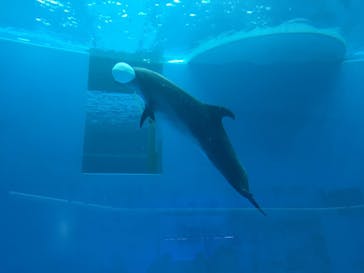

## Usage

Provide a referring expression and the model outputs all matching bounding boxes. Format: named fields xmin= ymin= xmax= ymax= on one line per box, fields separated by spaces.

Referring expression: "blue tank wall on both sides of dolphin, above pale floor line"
xmin=0 ymin=39 xmax=364 ymax=207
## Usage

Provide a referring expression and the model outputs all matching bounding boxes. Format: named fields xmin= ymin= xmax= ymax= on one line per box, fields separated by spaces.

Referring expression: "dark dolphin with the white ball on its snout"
xmin=112 ymin=62 xmax=266 ymax=215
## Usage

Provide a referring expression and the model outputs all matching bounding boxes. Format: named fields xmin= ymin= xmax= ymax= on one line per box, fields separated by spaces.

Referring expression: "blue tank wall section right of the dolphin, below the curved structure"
xmin=178 ymin=61 xmax=364 ymax=207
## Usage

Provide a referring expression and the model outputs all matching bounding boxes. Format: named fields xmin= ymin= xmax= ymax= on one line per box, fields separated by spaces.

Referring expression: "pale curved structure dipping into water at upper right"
xmin=185 ymin=21 xmax=346 ymax=64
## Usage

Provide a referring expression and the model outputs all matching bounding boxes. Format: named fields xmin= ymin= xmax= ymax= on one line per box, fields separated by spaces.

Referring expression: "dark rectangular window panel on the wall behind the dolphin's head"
xmin=82 ymin=50 xmax=162 ymax=174
